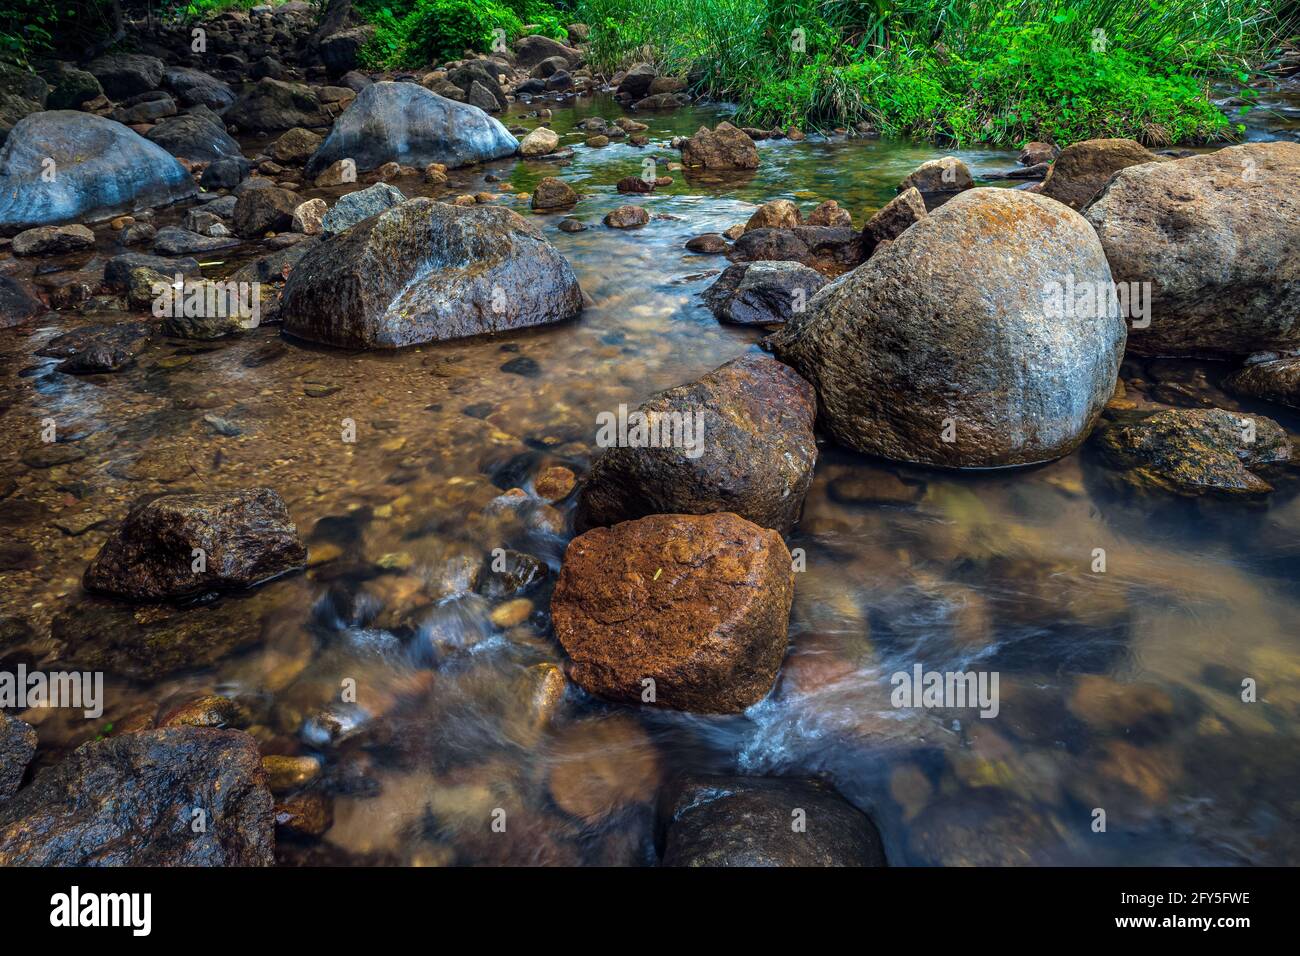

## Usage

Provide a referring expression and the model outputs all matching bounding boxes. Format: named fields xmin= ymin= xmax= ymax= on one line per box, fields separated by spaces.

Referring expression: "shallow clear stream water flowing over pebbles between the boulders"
xmin=0 ymin=93 xmax=1300 ymax=864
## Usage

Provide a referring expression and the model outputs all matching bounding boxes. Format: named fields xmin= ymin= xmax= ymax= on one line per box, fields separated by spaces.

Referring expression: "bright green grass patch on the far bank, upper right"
xmin=576 ymin=0 xmax=1295 ymax=146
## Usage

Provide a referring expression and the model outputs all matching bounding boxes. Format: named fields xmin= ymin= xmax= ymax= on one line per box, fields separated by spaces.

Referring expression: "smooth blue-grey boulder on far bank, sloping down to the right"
xmin=307 ymin=82 xmax=519 ymax=176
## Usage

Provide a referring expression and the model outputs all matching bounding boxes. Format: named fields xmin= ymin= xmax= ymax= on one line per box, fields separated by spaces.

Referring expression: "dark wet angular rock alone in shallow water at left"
xmin=85 ymin=488 xmax=307 ymax=601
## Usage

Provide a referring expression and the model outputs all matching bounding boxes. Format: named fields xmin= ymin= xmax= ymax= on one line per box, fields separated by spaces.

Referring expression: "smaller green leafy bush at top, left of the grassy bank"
xmin=359 ymin=0 xmax=567 ymax=69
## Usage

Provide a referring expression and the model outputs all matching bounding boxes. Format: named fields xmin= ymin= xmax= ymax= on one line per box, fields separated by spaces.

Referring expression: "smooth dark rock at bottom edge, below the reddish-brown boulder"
xmin=662 ymin=777 xmax=887 ymax=866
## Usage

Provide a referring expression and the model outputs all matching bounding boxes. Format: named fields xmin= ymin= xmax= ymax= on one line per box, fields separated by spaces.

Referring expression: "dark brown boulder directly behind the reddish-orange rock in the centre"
xmin=575 ymin=354 xmax=816 ymax=535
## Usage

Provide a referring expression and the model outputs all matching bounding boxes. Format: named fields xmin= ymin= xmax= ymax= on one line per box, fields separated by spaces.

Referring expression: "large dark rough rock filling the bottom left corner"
xmin=0 ymin=727 xmax=274 ymax=866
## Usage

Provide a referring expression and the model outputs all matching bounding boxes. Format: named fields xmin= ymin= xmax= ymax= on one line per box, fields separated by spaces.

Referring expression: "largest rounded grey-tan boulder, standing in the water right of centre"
xmin=771 ymin=189 xmax=1125 ymax=468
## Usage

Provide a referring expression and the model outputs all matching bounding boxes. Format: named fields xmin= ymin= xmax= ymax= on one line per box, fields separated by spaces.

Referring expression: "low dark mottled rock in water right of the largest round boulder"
xmin=1097 ymin=408 xmax=1291 ymax=497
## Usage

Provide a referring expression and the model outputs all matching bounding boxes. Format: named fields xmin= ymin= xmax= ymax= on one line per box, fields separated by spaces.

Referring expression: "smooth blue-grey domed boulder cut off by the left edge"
xmin=0 ymin=109 xmax=198 ymax=234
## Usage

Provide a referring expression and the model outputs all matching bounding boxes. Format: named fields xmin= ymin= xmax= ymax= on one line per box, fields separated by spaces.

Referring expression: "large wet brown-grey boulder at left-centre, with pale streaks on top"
xmin=281 ymin=199 xmax=582 ymax=349
